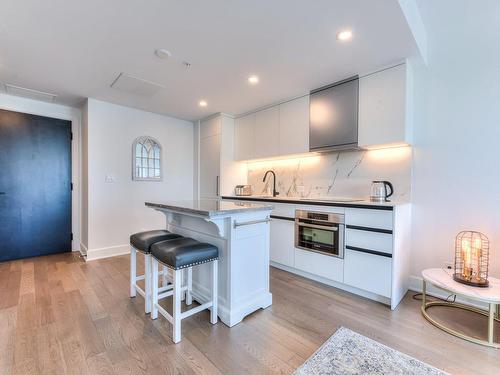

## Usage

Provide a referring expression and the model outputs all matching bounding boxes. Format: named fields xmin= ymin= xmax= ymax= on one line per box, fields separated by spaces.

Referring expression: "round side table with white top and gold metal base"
xmin=422 ymin=268 xmax=500 ymax=349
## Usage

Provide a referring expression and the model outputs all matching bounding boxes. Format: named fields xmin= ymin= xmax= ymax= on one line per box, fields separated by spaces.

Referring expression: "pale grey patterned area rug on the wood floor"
xmin=294 ymin=327 xmax=449 ymax=375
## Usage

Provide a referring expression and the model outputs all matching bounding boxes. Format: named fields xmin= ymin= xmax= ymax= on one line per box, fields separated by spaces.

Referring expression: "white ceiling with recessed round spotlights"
xmin=0 ymin=0 xmax=417 ymax=120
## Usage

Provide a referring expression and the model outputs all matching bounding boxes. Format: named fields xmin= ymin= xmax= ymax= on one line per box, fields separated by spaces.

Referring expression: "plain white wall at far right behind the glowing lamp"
xmin=412 ymin=0 xmax=500 ymax=277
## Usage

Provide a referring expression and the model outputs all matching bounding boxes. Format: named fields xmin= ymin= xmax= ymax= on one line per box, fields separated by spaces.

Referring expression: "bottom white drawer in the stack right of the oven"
xmin=344 ymin=249 xmax=392 ymax=298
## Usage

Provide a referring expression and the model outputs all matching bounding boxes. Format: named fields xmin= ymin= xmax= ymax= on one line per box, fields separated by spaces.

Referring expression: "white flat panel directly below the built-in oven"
xmin=295 ymin=249 xmax=344 ymax=282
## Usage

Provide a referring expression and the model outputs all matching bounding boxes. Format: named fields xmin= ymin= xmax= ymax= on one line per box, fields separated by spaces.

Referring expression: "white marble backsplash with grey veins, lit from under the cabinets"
xmin=247 ymin=147 xmax=412 ymax=200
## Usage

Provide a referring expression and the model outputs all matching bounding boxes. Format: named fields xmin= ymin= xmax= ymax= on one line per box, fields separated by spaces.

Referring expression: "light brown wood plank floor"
xmin=0 ymin=254 xmax=500 ymax=375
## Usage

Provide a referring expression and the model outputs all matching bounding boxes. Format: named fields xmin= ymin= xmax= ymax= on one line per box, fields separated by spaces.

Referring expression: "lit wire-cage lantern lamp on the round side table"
xmin=453 ymin=231 xmax=490 ymax=287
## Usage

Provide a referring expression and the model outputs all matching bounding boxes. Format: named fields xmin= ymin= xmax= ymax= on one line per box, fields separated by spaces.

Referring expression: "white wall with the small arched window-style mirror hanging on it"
xmin=87 ymin=99 xmax=194 ymax=259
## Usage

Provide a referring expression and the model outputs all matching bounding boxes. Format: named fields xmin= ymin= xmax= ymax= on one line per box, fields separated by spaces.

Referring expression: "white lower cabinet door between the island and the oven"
xmin=269 ymin=219 xmax=295 ymax=267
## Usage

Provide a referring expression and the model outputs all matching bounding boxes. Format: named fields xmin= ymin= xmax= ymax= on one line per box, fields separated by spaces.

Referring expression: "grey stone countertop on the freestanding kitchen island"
xmin=145 ymin=199 xmax=273 ymax=218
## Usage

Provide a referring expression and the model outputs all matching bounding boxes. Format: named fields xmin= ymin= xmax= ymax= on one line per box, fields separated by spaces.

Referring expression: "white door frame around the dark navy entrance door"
xmin=0 ymin=93 xmax=82 ymax=251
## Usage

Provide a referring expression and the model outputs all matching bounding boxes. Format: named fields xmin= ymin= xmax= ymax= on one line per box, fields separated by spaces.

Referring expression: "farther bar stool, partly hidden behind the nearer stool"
xmin=130 ymin=230 xmax=181 ymax=314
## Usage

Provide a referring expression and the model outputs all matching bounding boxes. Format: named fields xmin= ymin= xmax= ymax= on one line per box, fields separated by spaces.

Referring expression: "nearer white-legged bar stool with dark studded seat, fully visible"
xmin=151 ymin=237 xmax=219 ymax=343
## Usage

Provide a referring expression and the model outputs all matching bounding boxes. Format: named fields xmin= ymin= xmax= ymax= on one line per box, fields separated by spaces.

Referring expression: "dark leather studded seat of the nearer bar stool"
xmin=151 ymin=237 xmax=219 ymax=270
